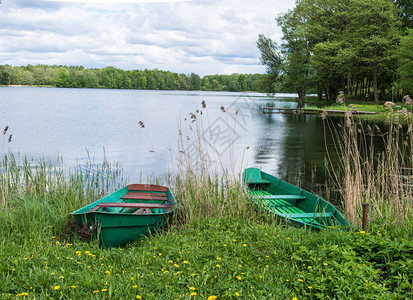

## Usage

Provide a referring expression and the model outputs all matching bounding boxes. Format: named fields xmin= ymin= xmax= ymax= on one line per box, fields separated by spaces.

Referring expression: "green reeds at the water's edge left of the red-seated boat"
xmin=0 ymin=146 xmax=123 ymax=240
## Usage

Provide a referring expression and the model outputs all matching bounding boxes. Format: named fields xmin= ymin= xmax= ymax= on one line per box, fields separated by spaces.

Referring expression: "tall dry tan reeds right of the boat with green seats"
xmin=322 ymin=94 xmax=413 ymax=230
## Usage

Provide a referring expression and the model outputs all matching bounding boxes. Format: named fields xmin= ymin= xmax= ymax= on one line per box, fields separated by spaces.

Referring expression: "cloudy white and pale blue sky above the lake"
xmin=0 ymin=0 xmax=295 ymax=75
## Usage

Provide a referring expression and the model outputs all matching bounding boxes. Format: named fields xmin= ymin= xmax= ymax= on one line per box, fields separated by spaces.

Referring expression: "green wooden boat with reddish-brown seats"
xmin=71 ymin=184 xmax=177 ymax=247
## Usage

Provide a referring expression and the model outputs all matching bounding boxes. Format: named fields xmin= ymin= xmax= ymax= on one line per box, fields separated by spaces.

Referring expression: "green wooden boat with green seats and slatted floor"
xmin=243 ymin=168 xmax=349 ymax=230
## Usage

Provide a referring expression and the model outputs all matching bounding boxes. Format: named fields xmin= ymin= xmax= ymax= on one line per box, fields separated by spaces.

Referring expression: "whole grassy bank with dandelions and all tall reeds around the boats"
xmin=0 ymin=95 xmax=413 ymax=299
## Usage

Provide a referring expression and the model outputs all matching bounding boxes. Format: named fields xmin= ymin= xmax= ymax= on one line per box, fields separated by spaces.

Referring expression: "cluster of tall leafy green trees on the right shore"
xmin=257 ymin=0 xmax=413 ymax=103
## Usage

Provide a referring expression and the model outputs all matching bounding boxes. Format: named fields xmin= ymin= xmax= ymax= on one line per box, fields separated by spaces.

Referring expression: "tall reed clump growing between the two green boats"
xmin=169 ymin=101 xmax=252 ymax=224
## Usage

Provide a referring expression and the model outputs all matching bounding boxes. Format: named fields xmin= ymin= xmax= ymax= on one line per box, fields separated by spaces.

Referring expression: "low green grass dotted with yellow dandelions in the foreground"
xmin=0 ymin=212 xmax=413 ymax=299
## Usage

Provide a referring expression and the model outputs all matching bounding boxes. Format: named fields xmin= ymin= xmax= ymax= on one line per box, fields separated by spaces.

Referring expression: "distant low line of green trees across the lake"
xmin=0 ymin=65 xmax=268 ymax=92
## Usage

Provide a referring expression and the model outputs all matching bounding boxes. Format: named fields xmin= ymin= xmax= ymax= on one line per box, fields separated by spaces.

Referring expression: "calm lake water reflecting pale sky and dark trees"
xmin=0 ymin=87 xmax=342 ymax=196
